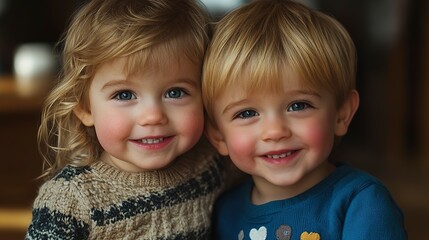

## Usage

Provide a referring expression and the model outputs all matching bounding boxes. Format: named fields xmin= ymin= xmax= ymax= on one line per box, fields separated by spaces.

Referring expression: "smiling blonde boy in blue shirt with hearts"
xmin=203 ymin=0 xmax=407 ymax=240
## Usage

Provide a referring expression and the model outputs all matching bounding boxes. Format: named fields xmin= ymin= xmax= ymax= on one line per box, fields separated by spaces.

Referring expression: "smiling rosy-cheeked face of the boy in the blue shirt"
xmin=207 ymin=69 xmax=358 ymax=199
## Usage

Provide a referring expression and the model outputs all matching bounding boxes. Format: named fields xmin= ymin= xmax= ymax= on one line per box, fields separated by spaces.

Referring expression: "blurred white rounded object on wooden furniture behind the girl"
xmin=13 ymin=43 xmax=57 ymax=96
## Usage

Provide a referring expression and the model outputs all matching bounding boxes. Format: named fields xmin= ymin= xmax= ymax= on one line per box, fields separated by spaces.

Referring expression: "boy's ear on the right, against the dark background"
xmin=335 ymin=90 xmax=359 ymax=136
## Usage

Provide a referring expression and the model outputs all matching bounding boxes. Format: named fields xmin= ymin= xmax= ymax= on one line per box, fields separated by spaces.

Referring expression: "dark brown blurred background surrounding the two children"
xmin=0 ymin=0 xmax=429 ymax=239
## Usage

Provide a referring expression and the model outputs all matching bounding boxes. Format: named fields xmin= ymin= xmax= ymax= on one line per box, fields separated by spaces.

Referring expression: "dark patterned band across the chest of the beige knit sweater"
xmin=91 ymin=159 xmax=221 ymax=226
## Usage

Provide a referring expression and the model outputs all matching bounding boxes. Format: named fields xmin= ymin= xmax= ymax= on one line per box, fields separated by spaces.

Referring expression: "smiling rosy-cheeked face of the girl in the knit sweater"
xmin=75 ymin=58 xmax=204 ymax=172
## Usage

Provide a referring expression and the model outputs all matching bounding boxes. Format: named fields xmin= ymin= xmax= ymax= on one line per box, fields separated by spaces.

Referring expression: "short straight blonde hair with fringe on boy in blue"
xmin=202 ymin=0 xmax=356 ymax=123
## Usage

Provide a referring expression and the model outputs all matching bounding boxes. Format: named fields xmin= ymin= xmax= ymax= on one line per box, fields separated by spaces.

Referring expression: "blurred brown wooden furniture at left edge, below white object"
xmin=0 ymin=76 xmax=45 ymax=239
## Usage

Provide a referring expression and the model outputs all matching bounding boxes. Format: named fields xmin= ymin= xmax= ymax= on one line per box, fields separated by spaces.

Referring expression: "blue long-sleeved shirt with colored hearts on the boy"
xmin=213 ymin=165 xmax=407 ymax=240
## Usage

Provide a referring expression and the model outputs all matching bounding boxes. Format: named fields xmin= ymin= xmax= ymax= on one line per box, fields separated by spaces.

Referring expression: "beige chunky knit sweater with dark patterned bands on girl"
xmin=26 ymin=143 xmax=225 ymax=239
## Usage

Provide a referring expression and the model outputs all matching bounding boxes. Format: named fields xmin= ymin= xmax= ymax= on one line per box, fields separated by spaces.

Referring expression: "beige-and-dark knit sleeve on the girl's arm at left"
xmin=25 ymin=174 xmax=90 ymax=239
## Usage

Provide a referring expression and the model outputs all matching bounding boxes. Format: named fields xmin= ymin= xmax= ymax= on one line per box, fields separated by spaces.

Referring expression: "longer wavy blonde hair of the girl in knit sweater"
xmin=38 ymin=0 xmax=210 ymax=177
